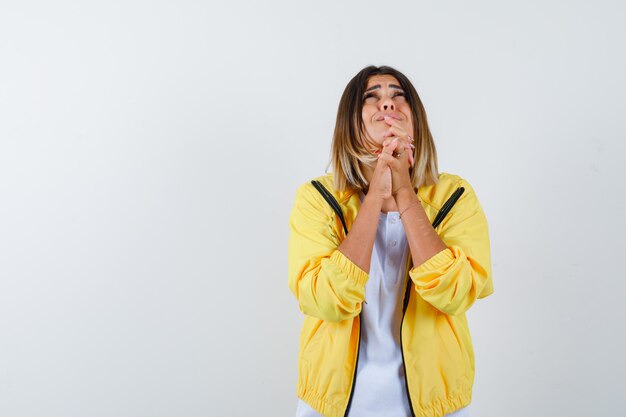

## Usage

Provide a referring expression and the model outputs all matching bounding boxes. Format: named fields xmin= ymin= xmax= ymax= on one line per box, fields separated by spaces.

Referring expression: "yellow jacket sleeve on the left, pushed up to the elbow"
xmin=288 ymin=183 xmax=369 ymax=321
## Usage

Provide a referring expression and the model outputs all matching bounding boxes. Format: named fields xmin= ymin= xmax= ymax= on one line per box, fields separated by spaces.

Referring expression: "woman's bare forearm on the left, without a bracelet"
xmin=337 ymin=195 xmax=383 ymax=274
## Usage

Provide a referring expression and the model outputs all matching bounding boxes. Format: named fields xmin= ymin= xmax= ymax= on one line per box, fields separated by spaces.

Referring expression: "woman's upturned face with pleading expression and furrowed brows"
xmin=362 ymin=75 xmax=413 ymax=150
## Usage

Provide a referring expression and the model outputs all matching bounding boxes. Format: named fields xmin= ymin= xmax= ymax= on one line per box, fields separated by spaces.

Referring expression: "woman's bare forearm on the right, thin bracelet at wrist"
xmin=395 ymin=188 xmax=447 ymax=267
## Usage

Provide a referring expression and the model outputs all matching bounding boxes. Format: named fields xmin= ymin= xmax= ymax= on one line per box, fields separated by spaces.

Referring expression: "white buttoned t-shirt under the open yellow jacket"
xmin=296 ymin=193 xmax=469 ymax=417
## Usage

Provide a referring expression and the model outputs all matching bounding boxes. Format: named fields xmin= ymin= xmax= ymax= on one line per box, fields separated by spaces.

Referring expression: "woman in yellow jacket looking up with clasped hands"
xmin=288 ymin=66 xmax=493 ymax=417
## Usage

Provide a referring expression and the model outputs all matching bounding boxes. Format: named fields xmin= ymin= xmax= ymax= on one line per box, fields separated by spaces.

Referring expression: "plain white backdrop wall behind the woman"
xmin=0 ymin=0 xmax=626 ymax=417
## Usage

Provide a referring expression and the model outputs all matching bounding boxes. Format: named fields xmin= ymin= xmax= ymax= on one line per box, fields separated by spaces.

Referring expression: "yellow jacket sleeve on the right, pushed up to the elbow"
xmin=409 ymin=179 xmax=493 ymax=315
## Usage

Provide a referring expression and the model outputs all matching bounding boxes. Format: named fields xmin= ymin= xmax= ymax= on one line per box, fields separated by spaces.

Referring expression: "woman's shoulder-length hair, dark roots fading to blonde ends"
xmin=326 ymin=65 xmax=439 ymax=192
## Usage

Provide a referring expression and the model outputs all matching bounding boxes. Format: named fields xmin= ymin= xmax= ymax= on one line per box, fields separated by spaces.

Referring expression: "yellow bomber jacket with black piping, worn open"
xmin=288 ymin=172 xmax=493 ymax=417
